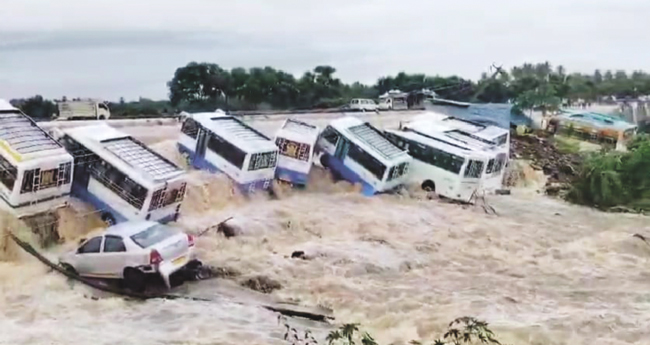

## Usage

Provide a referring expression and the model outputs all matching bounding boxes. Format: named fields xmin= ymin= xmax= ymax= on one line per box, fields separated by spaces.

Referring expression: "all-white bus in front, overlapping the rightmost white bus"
xmin=384 ymin=129 xmax=487 ymax=202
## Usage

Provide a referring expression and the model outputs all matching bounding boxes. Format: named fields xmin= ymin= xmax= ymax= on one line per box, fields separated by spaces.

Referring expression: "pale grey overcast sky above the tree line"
xmin=0 ymin=0 xmax=650 ymax=100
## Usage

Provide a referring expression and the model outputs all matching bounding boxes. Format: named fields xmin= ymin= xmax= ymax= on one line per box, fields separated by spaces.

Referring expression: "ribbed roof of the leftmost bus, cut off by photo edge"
xmin=0 ymin=100 xmax=65 ymax=155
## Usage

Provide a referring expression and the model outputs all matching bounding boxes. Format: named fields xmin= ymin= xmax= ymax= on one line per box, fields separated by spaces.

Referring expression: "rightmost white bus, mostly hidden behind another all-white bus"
xmin=402 ymin=113 xmax=510 ymax=191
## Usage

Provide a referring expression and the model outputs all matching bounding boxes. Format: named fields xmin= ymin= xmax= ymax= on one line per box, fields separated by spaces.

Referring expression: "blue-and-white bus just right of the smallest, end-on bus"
xmin=317 ymin=116 xmax=413 ymax=195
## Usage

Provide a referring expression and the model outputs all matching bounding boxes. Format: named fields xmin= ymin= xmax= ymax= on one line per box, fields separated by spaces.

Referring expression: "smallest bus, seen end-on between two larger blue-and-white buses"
xmin=275 ymin=118 xmax=320 ymax=185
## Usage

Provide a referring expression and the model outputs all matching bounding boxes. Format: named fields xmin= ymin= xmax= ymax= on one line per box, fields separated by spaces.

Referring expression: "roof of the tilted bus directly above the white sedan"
xmin=63 ymin=123 xmax=185 ymax=182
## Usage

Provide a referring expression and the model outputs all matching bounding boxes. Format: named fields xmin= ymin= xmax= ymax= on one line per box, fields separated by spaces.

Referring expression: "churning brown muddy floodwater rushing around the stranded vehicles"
xmin=0 ymin=113 xmax=650 ymax=345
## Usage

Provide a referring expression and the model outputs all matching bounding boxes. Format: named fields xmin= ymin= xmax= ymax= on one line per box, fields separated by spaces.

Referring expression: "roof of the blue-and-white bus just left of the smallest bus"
xmin=190 ymin=112 xmax=277 ymax=153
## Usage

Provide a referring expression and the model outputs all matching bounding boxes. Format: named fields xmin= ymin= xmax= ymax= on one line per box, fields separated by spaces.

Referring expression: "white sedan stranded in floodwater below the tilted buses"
xmin=59 ymin=221 xmax=201 ymax=292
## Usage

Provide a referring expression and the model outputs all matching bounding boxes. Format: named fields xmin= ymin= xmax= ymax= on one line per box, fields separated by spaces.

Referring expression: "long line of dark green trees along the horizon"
xmin=12 ymin=62 xmax=650 ymax=118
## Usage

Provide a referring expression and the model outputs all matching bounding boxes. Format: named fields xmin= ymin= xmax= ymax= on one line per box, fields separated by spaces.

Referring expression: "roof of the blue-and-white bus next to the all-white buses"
xmin=330 ymin=116 xmax=408 ymax=160
